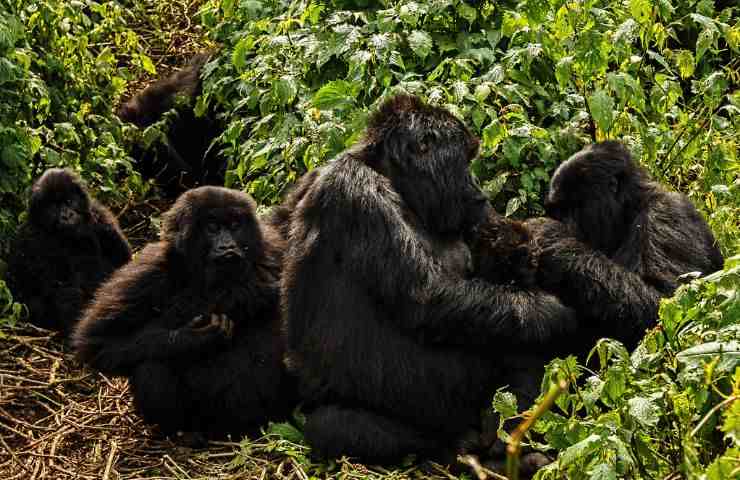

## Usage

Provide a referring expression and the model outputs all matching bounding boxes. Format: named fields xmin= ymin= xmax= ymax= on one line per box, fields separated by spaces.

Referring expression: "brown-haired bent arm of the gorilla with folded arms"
xmin=72 ymin=244 xmax=229 ymax=375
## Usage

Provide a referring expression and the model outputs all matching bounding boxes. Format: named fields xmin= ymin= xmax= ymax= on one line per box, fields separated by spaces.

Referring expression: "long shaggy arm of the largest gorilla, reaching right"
xmin=316 ymin=181 xmax=575 ymax=346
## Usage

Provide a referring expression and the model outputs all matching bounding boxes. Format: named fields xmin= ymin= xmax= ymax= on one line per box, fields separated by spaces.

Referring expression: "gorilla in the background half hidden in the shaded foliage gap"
xmin=117 ymin=53 xmax=225 ymax=195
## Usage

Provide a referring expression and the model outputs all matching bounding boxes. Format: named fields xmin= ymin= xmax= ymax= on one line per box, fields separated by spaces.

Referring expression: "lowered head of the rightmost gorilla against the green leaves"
xmin=545 ymin=141 xmax=649 ymax=255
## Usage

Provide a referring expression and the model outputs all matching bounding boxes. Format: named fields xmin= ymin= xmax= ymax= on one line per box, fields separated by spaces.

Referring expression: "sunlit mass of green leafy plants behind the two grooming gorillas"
xmin=201 ymin=0 xmax=740 ymax=246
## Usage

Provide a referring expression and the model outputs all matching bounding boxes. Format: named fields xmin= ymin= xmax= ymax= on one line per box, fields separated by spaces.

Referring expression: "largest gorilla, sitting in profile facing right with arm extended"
xmin=281 ymin=96 xmax=574 ymax=461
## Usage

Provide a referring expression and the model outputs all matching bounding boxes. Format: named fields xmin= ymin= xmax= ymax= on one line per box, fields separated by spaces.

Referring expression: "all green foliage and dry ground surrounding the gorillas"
xmin=0 ymin=0 xmax=740 ymax=480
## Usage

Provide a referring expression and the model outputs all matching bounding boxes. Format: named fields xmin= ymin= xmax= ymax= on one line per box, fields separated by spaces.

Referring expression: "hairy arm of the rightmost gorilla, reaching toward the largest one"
xmin=527 ymin=218 xmax=661 ymax=341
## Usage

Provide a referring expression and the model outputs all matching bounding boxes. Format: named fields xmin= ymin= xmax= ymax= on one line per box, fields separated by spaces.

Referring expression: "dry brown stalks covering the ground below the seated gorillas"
xmin=0 ymin=325 xmax=468 ymax=480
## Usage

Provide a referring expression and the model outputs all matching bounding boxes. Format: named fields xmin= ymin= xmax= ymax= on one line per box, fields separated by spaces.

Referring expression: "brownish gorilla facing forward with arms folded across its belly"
xmin=73 ymin=187 xmax=293 ymax=441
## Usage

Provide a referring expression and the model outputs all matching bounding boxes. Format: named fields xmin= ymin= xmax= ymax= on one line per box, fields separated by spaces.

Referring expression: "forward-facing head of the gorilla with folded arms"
xmin=162 ymin=187 xmax=263 ymax=285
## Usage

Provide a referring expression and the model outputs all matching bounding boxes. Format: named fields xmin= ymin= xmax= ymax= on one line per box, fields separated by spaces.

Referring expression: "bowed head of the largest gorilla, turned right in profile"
xmin=365 ymin=95 xmax=486 ymax=233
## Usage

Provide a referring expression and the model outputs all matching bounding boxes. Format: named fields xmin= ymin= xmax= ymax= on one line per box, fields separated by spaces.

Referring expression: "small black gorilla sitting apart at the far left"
xmin=8 ymin=168 xmax=131 ymax=333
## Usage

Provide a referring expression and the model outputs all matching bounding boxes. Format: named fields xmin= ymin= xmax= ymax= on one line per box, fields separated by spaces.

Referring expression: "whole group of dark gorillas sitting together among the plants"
xmin=4 ymin=93 xmax=723 ymax=467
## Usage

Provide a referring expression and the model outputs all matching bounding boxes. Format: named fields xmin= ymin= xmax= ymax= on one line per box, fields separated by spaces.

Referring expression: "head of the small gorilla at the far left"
xmin=29 ymin=168 xmax=91 ymax=234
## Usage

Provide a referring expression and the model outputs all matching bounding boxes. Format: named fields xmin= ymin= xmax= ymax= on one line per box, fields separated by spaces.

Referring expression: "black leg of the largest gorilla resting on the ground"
xmin=305 ymin=405 xmax=443 ymax=462
